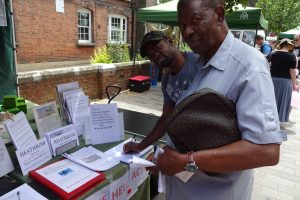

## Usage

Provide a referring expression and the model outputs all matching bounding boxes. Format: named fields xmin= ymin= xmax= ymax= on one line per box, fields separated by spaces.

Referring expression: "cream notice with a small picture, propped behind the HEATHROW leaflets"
xmin=32 ymin=101 xmax=62 ymax=138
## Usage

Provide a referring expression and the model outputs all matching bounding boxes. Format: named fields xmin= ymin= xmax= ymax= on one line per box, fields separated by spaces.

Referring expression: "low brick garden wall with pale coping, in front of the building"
xmin=19 ymin=62 xmax=149 ymax=104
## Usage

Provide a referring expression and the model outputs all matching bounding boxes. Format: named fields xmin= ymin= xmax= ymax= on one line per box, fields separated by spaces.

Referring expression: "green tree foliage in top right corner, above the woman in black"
xmin=256 ymin=0 xmax=300 ymax=33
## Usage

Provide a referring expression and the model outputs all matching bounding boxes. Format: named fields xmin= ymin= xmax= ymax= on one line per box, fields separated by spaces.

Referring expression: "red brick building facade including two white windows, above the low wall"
xmin=13 ymin=0 xmax=132 ymax=64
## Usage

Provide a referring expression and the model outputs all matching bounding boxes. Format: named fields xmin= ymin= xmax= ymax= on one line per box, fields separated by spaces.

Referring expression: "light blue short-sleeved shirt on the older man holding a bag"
xmin=166 ymin=32 xmax=286 ymax=200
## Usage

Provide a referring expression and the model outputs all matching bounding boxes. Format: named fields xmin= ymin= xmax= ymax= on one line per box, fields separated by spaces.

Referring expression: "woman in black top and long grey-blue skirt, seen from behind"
xmin=268 ymin=38 xmax=297 ymax=122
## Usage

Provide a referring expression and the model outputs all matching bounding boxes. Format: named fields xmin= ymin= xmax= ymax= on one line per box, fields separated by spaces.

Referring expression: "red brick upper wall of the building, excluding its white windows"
xmin=13 ymin=0 xmax=131 ymax=64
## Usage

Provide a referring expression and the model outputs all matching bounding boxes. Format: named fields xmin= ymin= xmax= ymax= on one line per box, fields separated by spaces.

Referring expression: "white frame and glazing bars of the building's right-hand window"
xmin=107 ymin=14 xmax=127 ymax=44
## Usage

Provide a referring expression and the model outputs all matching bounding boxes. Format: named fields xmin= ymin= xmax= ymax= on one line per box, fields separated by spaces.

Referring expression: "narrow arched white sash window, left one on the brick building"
xmin=77 ymin=8 xmax=92 ymax=43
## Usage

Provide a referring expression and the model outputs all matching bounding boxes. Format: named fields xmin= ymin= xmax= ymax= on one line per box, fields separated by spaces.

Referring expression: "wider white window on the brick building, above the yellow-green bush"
xmin=108 ymin=15 xmax=127 ymax=44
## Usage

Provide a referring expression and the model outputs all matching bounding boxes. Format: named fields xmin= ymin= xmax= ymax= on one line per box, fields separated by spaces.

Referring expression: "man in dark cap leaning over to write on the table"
xmin=123 ymin=31 xmax=199 ymax=153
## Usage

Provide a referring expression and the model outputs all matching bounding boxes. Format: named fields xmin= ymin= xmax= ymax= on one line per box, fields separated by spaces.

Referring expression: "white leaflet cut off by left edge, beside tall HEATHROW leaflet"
xmin=0 ymin=138 xmax=14 ymax=177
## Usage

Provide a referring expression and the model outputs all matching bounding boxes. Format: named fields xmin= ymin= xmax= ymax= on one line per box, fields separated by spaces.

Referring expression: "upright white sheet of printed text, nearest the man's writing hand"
xmin=90 ymin=103 xmax=120 ymax=145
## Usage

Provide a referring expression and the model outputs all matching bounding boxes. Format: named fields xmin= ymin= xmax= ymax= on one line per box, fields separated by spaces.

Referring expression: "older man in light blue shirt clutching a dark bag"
xmin=148 ymin=0 xmax=286 ymax=200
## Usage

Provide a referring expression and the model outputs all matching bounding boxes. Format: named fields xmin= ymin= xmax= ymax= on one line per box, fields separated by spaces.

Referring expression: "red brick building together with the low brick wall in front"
xmin=13 ymin=0 xmax=157 ymax=104
